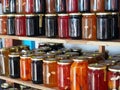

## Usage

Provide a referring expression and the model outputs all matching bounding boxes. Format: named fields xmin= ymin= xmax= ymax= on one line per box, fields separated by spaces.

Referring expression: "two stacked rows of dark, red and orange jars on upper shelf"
xmin=0 ymin=0 xmax=120 ymax=40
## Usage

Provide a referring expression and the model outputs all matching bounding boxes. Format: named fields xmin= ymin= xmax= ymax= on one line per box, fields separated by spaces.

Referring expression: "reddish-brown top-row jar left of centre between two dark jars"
xmin=45 ymin=0 xmax=56 ymax=14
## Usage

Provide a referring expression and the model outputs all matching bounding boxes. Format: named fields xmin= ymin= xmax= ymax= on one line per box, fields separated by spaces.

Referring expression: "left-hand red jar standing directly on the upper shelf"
xmin=15 ymin=15 xmax=26 ymax=36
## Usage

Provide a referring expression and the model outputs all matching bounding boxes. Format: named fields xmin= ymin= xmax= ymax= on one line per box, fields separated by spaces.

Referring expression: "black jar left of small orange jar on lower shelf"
xmin=9 ymin=53 xmax=20 ymax=78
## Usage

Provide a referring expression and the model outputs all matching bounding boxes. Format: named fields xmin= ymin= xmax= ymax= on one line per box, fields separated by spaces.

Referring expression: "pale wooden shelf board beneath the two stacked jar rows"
xmin=0 ymin=35 xmax=120 ymax=46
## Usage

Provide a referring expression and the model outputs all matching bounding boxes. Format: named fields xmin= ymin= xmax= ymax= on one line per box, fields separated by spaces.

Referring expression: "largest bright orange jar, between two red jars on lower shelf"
xmin=70 ymin=57 xmax=88 ymax=90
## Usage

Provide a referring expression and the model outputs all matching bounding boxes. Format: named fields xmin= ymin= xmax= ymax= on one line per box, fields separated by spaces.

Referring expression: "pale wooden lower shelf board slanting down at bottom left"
xmin=0 ymin=76 xmax=58 ymax=90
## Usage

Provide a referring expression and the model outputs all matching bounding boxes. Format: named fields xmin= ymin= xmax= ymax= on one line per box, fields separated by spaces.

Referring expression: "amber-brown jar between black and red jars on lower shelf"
xmin=43 ymin=58 xmax=57 ymax=87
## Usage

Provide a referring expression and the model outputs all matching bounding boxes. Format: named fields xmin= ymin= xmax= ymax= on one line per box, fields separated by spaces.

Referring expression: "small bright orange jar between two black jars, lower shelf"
xmin=20 ymin=55 xmax=31 ymax=81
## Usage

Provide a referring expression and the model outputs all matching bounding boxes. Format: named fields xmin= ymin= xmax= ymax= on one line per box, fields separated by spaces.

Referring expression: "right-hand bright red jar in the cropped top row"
xmin=66 ymin=0 xmax=78 ymax=13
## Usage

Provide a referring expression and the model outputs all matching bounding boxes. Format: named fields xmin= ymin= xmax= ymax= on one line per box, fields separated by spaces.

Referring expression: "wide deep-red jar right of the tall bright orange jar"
xmin=88 ymin=64 xmax=108 ymax=90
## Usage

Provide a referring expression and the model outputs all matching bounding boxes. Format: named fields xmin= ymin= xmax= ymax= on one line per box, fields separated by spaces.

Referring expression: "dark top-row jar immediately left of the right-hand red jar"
xmin=56 ymin=0 xmax=66 ymax=13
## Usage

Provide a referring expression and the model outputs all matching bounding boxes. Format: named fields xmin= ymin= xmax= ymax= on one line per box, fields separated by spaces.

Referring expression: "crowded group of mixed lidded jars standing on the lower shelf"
xmin=0 ymin=43 xmax=120 ymax=90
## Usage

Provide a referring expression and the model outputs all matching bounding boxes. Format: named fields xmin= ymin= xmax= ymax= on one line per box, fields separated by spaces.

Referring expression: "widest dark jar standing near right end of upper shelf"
xmin=97 ymin=13 xmax=112 ymax=40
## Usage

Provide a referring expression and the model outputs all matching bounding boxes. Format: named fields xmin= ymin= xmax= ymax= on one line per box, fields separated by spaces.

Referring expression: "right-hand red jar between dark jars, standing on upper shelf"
xmin=58 ymin=14 xmax=69 ymax=38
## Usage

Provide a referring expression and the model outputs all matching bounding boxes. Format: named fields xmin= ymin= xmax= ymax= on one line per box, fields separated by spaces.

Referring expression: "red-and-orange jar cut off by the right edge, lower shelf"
xmin=108 ymin=65 xmax=120 ymax=90
